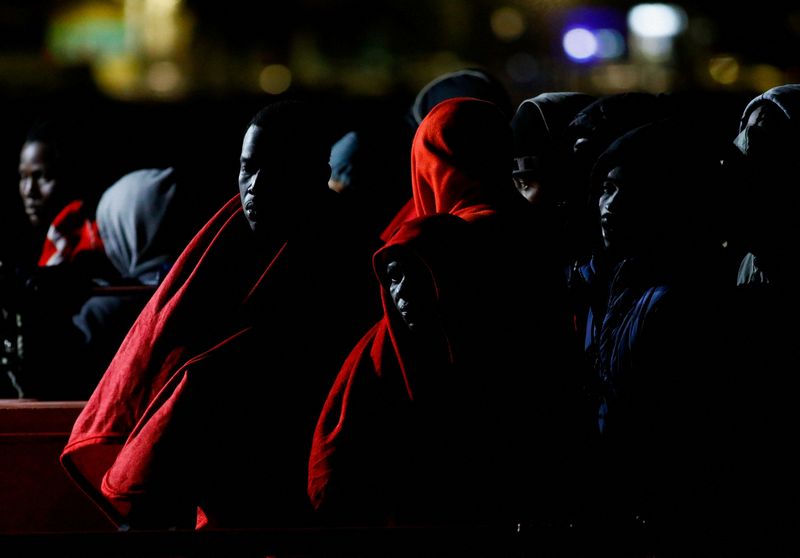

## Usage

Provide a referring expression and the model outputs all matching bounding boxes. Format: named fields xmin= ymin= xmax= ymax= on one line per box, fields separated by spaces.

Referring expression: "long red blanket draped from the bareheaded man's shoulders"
xmin=61 ymin=195 xmax=286 ymax=524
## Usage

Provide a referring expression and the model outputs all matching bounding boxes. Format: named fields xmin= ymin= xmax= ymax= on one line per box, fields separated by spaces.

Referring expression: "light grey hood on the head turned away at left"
xmin=97 ymin=168 xmax=177 ymax=284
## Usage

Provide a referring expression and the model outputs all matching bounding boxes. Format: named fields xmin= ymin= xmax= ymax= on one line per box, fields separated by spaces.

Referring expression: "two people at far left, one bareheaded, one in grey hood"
xmin=0 ymin=119 xmax=206 ymax=400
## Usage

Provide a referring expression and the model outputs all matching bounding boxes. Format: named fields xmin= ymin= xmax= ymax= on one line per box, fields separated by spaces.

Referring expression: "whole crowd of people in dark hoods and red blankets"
xmin=2 ymin=69 xmax=800 ymax=552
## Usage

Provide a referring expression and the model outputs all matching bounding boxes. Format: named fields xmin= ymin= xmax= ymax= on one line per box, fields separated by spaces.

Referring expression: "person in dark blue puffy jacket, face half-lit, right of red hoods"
xmin=592 ymin=119 xmax=732 ymax=534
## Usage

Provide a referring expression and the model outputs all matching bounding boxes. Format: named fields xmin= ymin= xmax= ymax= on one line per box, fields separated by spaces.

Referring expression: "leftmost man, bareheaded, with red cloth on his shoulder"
xmin=5 ymin=118 xmax=114 ymax=399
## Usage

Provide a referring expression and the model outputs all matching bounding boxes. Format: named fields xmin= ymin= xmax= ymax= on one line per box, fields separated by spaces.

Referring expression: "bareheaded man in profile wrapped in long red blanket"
xmin=61 ymin=100 xmax=366 ymax=529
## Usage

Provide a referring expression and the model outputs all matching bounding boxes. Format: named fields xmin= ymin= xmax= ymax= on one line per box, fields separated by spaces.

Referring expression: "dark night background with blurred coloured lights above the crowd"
xmin=0 ymin=0 xmax=800 ymax=208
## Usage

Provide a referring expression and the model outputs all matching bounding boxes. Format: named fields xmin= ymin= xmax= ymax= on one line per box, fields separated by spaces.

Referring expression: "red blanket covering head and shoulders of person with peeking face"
xmin=308 ymin=215 xmax=482 ymax=519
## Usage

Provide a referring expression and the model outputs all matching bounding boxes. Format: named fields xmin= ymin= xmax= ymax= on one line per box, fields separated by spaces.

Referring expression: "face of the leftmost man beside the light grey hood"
xmin=19 ymin=141 xmax=59 ymax=227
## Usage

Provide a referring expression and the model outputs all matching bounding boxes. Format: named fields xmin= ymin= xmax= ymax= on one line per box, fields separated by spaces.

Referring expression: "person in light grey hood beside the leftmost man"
xmin=20 ymin=168 xmax=188 ymax=401
